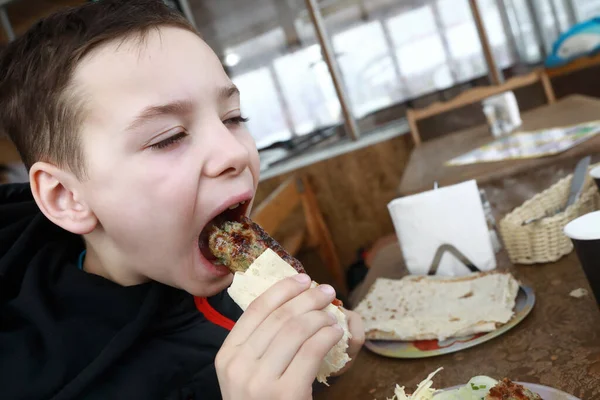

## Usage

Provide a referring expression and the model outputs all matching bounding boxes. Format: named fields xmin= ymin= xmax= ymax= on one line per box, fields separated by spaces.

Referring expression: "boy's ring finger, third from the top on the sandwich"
xmin=259 ymin=310 xmax=336 ymax=379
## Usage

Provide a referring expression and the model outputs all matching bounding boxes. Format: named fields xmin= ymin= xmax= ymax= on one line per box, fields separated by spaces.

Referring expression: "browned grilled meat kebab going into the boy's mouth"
xmin=208 ymin=217 xmax=304 ymax=273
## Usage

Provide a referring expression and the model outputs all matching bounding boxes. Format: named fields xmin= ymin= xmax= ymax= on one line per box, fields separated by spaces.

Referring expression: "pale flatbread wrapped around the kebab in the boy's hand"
xmin=227 ymin=249 xmax=352 ymax=384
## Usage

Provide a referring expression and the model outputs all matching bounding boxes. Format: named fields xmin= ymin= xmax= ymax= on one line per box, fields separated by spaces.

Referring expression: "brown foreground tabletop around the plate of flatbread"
xmin=315 ymin=165 xmax=600 ymax=400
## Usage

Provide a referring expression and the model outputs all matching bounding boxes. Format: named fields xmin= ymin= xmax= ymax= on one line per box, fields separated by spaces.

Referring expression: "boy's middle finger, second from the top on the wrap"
xmin=246 ymin=285 xmax=335 ymax=358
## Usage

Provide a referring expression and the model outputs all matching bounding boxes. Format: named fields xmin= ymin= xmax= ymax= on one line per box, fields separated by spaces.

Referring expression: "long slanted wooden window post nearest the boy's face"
xmin=306 ymin=0 xmax=360 ymax=140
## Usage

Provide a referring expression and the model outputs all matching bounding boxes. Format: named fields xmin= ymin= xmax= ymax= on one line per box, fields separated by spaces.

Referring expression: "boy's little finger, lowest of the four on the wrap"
xmin=282 ymin=324 xmax=344 ymax=385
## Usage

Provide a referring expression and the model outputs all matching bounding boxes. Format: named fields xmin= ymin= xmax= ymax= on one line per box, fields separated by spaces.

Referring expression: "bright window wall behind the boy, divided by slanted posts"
xmin=198 ymin=0 xmax=600 ymax=152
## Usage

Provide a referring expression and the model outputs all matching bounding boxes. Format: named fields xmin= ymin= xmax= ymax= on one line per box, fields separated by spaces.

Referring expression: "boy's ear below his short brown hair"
xmin=29 ymin=162 xmax=98 ymax=235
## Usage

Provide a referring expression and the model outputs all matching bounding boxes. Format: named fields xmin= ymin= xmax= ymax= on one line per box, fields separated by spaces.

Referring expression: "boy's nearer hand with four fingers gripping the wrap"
xmin=215 ymin=274 xmax=343 ymax=400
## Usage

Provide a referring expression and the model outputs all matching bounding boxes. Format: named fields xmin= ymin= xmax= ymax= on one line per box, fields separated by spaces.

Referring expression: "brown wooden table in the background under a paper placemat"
xmin=399 ymin=95 xmax=600 ymax=196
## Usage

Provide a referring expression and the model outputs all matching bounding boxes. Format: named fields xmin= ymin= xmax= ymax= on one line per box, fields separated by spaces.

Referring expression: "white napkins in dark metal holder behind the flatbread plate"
xmin=388 ymin=181 xmax=496 ymax=276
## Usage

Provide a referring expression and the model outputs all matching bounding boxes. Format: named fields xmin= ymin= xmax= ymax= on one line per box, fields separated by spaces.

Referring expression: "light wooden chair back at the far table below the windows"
xmin=406 ymin=69 xmax=556 ymax=146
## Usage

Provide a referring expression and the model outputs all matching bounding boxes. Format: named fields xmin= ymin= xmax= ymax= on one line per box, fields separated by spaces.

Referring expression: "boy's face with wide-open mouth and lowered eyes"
xmin=74 ymin=27 xmax=259 ymax=296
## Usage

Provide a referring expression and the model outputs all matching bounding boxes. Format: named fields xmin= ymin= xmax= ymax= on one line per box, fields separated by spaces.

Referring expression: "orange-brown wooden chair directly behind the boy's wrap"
xmin=251 ymin=176 xmax=347 ymax=296
